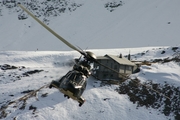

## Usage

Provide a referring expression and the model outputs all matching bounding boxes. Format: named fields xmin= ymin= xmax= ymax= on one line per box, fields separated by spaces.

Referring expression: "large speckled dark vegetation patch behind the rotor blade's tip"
xmin=0 ymin=0 xmax=82 ymax=24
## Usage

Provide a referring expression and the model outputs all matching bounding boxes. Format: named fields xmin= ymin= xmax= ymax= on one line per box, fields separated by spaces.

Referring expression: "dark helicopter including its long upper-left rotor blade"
xmin=18 ymin=4 xmax=105 ymax=106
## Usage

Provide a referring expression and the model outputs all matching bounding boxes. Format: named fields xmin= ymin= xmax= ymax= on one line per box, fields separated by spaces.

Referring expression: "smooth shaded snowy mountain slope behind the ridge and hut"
xmin=0 ymin=0 xmax=180 ymax=50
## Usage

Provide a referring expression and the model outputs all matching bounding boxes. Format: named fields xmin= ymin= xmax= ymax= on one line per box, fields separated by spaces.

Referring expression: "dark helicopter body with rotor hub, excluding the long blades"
xmin=49 ymin=52 xmax=96 ymax=106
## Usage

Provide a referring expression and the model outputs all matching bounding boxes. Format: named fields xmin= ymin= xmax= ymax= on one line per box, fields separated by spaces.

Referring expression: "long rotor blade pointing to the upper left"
xmin=18 ymin=4 xmax=84 ymax=54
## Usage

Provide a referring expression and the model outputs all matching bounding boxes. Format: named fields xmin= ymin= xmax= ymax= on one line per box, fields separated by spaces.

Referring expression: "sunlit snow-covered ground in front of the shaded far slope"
xmin=0 ymin=45 xmax=180 ymax=120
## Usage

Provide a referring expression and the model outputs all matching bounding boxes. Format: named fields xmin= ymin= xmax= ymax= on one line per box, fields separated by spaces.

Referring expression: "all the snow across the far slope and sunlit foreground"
xmin=0 ymin=0 xmax=180 ymax=120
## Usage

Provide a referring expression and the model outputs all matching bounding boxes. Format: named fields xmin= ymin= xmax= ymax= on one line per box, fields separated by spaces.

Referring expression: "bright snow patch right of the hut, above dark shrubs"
xmin=135 ymin=62 xmax=180 ymax=87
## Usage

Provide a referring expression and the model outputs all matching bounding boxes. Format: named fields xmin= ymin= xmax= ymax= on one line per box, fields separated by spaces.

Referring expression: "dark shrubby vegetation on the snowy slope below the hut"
xmin=117 ymin=79 xmax=180 ymax=120
